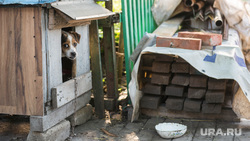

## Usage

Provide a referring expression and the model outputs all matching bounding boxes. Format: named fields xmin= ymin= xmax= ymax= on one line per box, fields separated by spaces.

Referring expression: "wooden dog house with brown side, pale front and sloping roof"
xmin=0 ymin=0 xmax=114 ymax=131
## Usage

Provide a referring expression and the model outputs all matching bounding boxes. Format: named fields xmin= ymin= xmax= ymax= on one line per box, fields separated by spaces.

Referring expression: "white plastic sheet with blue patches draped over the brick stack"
xmin=129 ymin=29 xmax=250 ymax=121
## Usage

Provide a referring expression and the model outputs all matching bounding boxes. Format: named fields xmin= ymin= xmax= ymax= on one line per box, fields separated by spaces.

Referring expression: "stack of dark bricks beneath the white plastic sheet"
xmin=138 ymin=54 xmax=235 ymax=114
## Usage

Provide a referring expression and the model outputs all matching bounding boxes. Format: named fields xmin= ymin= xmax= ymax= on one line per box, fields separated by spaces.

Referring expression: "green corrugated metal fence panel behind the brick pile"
xmin=121 ymin=0 xmax=157 ymax=86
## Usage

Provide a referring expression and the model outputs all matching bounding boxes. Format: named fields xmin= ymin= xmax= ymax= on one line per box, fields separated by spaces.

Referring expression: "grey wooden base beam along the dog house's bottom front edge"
xmin=30 ymin=91 xmax=91 ymax=132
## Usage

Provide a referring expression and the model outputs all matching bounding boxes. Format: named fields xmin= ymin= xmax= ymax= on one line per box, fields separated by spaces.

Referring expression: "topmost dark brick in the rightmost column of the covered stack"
xmin=208 ymin=78 xmax=227 ymax=90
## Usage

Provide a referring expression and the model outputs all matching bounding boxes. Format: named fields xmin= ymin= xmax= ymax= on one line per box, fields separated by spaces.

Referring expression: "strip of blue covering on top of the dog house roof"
xmin=0 ymin=0 xmax=56 ymax=5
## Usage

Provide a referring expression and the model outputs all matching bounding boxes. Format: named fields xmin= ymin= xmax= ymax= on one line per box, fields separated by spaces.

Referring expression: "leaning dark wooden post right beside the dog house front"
xmin=89 ymin=20 xmax=105 ymax=119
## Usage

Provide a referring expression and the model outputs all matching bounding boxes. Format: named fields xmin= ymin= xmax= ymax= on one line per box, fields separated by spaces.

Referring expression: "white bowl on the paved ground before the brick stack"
xmin=155 ymin=123 xmax=187 ymax=138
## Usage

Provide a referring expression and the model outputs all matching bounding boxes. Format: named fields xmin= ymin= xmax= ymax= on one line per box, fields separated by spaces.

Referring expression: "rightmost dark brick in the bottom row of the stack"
xmin=202 ymin=103 xmax=222 ymax=114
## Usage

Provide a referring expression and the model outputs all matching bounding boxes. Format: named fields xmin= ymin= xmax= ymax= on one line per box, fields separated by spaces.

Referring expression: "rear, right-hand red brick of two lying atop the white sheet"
xmin=178 ymin=32 xmax=222 ymax=46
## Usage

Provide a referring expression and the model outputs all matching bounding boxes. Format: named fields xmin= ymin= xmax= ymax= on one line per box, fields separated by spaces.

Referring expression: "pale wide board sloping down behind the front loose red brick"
xmin=153 ymin=16 xmax=184 ymax=37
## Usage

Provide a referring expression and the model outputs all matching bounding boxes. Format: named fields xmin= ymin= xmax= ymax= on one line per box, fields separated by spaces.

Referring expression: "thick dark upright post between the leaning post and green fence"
xmin=103 ymin=0 xmax=118 ymax=110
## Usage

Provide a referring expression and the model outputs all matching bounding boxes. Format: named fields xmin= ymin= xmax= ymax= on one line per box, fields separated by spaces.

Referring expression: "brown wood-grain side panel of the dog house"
xmin=0 ymin=7 xmax=43 ymax=115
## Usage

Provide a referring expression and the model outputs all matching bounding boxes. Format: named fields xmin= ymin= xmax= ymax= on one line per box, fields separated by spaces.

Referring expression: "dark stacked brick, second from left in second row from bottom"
xmin=165 ymin=85 xmax=185 ymax=97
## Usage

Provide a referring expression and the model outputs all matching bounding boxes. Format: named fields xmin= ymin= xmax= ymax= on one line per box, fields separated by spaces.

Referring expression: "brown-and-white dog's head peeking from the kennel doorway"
xmin=62 ymin=31 xmax=81 ymax=60
